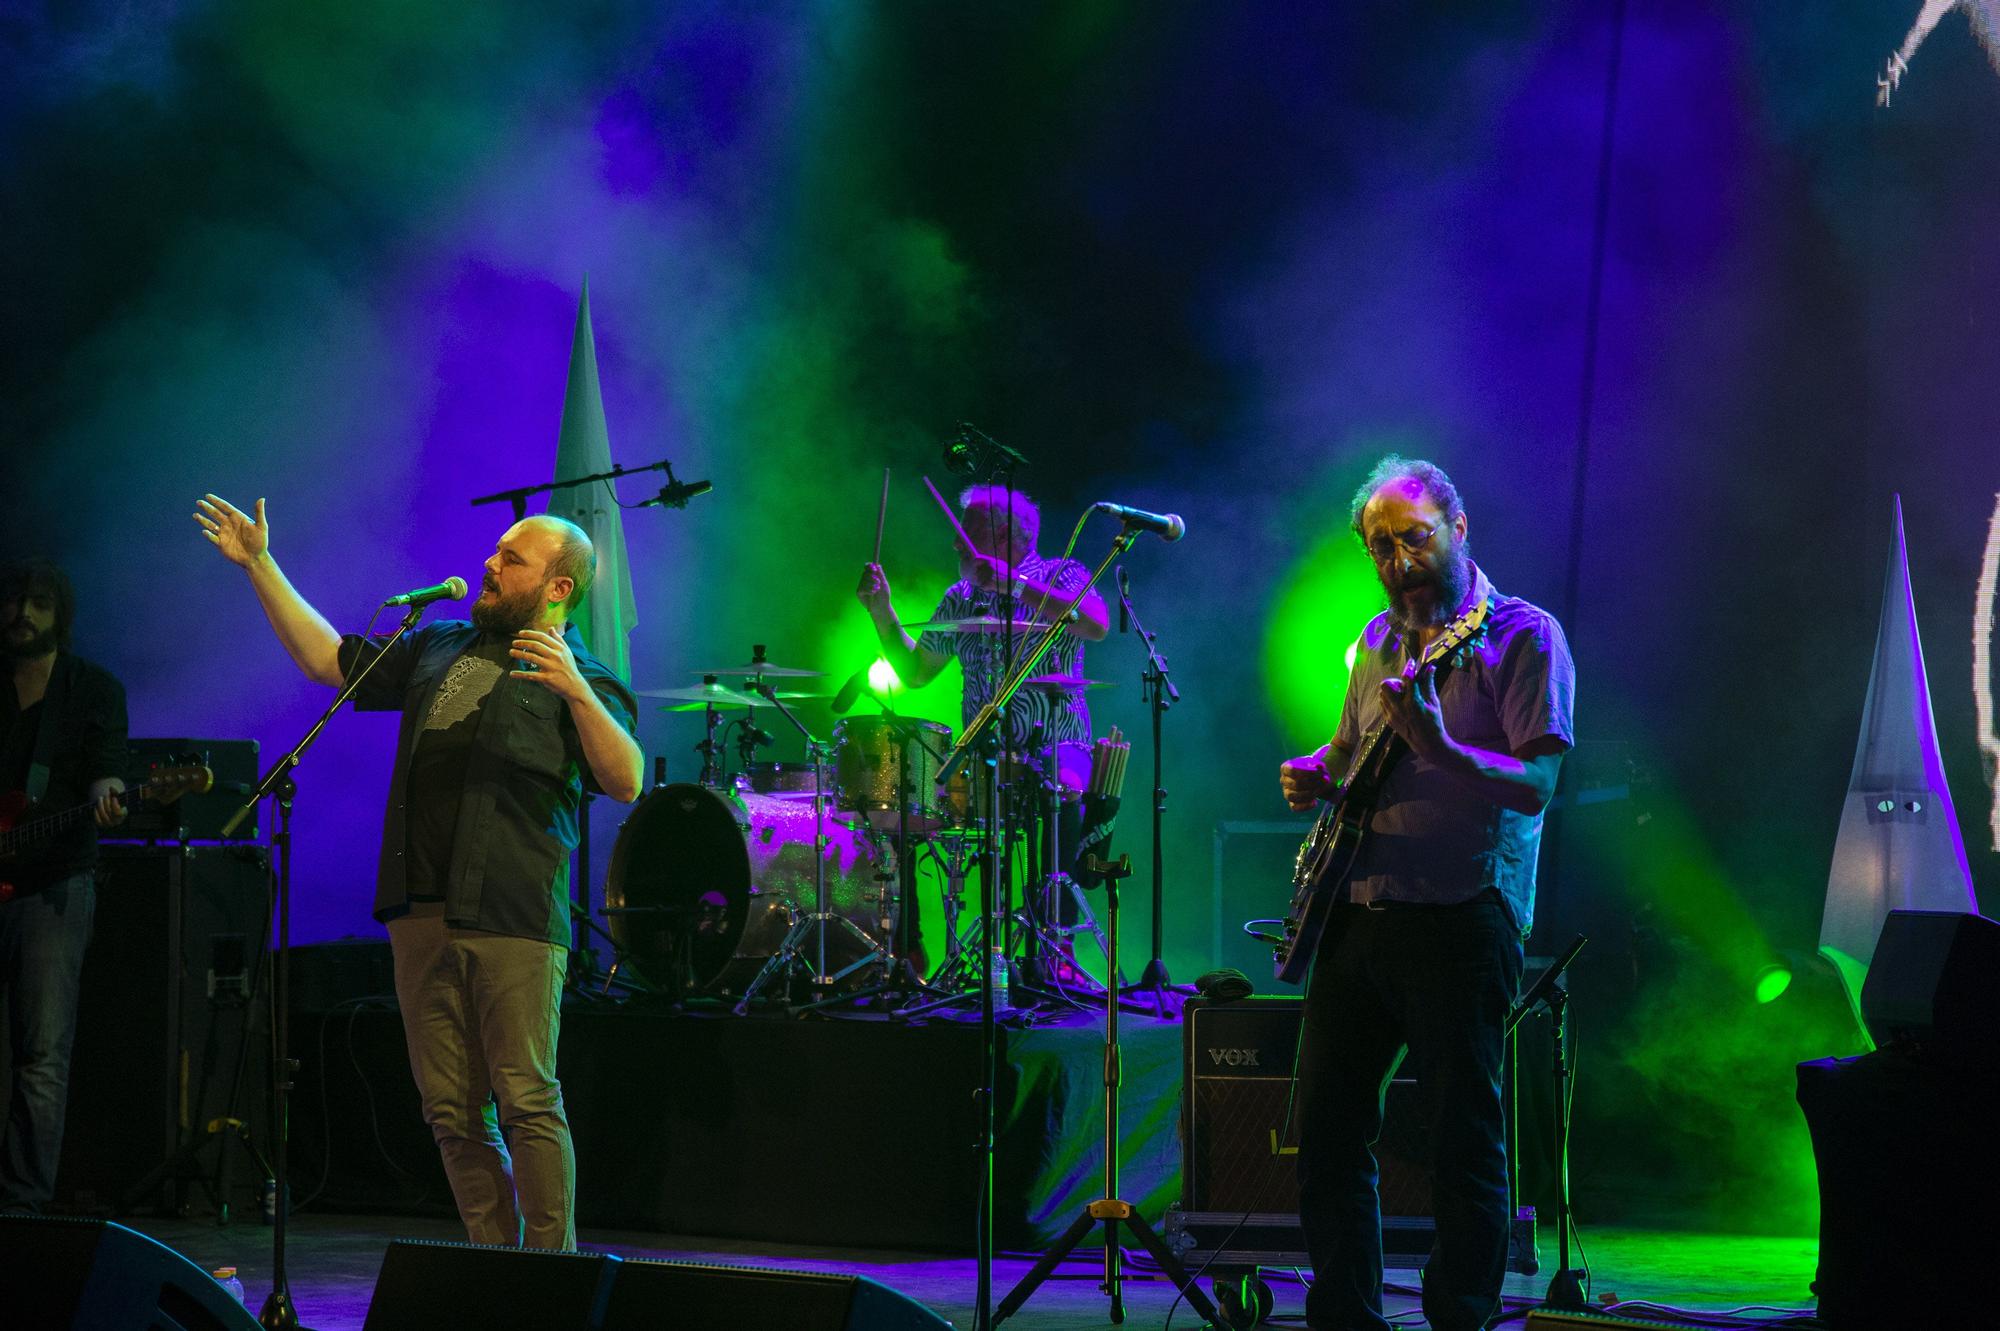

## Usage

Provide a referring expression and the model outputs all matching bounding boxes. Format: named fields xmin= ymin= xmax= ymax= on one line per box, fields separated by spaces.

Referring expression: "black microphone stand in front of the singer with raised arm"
xmin=222 ymin=606 xmax=424 ymax=1331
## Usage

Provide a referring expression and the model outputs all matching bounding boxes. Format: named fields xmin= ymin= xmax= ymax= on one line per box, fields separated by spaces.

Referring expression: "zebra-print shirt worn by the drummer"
xmin=916 ymin=556 xmax=1090 ymax=751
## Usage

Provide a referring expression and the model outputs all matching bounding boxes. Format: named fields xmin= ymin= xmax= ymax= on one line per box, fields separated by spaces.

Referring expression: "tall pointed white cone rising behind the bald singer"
xmin=548 ymin=278 xmax=638 ymax=679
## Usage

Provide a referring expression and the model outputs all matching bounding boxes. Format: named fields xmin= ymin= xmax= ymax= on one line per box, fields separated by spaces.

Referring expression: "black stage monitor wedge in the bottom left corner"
xmin=0 ymin=1215 xmax=258 ymax=1331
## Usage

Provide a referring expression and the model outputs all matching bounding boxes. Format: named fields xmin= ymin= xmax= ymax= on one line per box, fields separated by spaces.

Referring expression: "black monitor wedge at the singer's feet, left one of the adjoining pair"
xmin=364 ymin=1239 xmax=620 ymax=1331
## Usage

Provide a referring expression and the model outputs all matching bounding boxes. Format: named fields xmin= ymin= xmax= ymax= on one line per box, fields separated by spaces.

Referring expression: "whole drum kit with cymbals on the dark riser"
xmin=604 ymin=628 xmax=1128 ymax=1013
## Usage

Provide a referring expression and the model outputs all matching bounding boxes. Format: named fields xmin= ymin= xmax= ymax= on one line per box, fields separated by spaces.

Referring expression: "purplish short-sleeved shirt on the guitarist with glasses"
xmin=1334 ymin=568 xmax=1576 ymax=935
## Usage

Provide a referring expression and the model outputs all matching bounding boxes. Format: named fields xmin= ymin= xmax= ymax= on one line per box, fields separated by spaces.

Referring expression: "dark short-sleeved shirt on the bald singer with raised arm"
xmin=340 ymin=620 xmax=638 ymax=945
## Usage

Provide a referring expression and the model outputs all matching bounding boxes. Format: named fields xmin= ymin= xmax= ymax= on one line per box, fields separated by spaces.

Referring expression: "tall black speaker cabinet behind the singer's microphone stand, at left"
xmin=54 ymin=843 xmax=270 ymax=1215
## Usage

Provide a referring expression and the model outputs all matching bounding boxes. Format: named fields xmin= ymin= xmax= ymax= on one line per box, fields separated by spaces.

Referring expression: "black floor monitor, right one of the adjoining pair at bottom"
xmin=604 ymin=1257 xmax=952 ymax=1331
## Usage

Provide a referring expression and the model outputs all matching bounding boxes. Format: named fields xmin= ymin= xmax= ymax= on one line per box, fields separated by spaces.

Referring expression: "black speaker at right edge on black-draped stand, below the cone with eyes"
xmin=1862 ymin=911 xmax=2000 ymax=1063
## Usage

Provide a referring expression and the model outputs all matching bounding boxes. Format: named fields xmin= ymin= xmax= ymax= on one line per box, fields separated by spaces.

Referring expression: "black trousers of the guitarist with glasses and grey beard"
xmin=1298 ymin=895 xmax=1522 ymax=1331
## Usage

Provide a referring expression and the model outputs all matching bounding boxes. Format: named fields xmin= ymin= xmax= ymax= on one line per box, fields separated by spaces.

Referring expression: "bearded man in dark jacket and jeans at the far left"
xmin=0 ymin=560 xmax=126 ymax=1213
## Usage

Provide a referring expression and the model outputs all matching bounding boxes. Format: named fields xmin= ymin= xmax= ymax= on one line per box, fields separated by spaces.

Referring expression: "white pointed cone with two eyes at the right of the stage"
xmin=1820 ymin=496 xmax=1978 ymax=1013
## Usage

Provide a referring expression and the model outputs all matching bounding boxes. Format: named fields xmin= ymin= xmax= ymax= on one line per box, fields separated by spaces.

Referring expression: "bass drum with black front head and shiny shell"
xmin=604 ymin=783 xmax=894 ymax=995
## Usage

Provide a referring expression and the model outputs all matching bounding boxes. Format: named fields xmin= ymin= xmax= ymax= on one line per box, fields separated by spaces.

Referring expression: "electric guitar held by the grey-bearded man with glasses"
xmin=1272 ymin=598 xmax=1492 ymax=985
